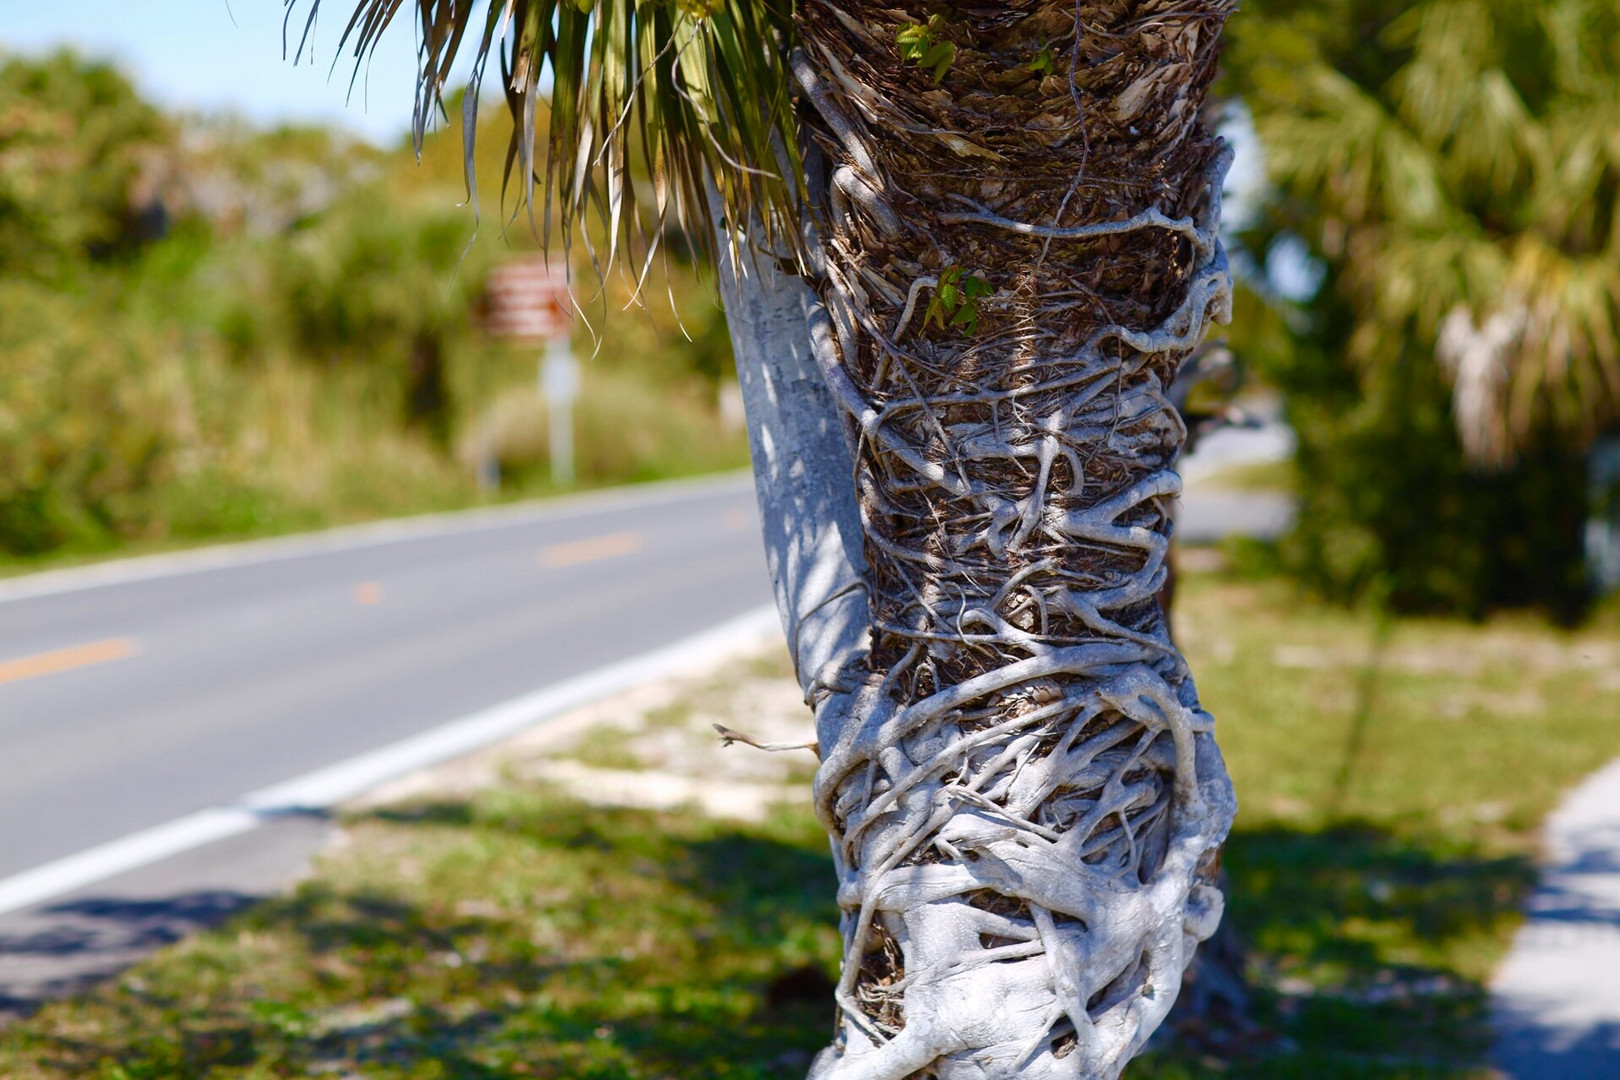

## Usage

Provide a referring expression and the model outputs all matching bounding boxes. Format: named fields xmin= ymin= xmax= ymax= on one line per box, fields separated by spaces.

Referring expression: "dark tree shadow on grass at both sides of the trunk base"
xmin=0 ymin=800 xmax=1534 ymax=1080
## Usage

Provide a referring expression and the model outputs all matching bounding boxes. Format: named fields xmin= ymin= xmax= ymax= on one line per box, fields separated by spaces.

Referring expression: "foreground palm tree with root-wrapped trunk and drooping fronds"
xmin=325 ymin=0 xmax=1234 ymax=1080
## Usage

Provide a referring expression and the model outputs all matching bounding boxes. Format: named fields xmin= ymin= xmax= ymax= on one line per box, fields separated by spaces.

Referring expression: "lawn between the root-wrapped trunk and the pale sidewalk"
xmin=1134 ymin=575 xmax=1620 ymax=1080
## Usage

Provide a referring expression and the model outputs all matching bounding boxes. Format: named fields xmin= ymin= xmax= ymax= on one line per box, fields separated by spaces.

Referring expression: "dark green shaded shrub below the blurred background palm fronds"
xmin=1277 ymin=338 xmax=1589 ymax=622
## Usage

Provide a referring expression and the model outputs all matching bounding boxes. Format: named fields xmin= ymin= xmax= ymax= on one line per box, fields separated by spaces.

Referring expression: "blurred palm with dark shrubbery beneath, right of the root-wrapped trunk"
xmin=1228 ymin=0 xmax=1620 ymax=615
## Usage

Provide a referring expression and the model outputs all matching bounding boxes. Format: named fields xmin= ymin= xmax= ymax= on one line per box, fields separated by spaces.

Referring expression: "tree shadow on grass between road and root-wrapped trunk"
xmin=12 ymin=800 xmax=838 ymax=1080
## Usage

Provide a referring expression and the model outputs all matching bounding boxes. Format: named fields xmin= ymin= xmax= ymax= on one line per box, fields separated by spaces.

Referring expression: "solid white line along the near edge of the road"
xmin=0 ymin=607 xmax=781 ymax=915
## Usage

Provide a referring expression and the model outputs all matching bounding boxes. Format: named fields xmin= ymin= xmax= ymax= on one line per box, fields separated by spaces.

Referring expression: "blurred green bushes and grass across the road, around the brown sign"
xmin=0 ymin=53 xmax=747 ymax=555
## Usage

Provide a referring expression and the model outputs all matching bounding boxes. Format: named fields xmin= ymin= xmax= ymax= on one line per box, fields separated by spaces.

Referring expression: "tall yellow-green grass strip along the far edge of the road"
xmin=0 ymin=363 xmax=748 ymax=578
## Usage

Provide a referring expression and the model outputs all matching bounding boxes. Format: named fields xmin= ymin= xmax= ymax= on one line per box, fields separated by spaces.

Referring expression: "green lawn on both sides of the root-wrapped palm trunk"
xmin=0 ymin=573 xmax=1620 ymax=1080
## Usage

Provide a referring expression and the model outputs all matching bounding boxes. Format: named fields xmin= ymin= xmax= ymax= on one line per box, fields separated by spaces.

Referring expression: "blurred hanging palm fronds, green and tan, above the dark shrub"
xmin=1233 ymin=0 xmax=1620 ymax=468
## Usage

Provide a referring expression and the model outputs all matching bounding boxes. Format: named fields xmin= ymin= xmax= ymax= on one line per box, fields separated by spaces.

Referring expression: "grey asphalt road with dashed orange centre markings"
xmin=0 ymin=476 xmax=1290 ymax=1022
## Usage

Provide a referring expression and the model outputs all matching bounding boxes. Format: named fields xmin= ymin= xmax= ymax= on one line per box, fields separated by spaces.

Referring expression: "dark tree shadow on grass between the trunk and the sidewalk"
xmin=1128 ymin=823 xmax=1536 ymax=1080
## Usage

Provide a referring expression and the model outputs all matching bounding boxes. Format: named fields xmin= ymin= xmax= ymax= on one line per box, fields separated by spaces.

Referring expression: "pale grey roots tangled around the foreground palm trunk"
xmin=800 ymin=139 xmax=1234 ymax=1080
